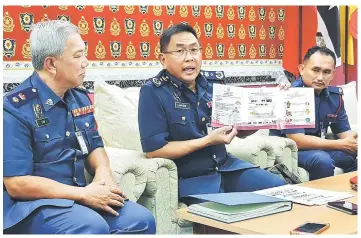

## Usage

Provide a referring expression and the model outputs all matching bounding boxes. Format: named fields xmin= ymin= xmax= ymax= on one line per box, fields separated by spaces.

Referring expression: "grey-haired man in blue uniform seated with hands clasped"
xmin=3 ymin=21 xmax=155 ymax=234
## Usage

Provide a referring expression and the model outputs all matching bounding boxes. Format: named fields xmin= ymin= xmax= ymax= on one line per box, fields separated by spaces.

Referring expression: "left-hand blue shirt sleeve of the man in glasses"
xmin=138 ymin=84 xmax=169 ymax=152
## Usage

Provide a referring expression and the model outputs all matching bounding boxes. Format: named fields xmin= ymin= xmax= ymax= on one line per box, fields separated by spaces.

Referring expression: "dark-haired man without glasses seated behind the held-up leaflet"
xmin=270 ymin=46 xmax=357 ymax=180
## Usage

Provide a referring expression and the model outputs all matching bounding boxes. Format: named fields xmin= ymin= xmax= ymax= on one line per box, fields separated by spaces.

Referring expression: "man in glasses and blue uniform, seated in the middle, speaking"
xmin=138 ymin=24 xmax=285 ymax=205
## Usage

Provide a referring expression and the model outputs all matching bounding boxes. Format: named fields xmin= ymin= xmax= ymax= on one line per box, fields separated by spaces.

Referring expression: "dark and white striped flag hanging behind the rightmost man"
xmin=316 ymin=6 xmax=341 ymax=67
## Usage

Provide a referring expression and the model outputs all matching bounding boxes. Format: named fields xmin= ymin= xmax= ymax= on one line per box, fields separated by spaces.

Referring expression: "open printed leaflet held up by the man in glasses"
xmin=211 ymin=84 xmax=315 ymax=130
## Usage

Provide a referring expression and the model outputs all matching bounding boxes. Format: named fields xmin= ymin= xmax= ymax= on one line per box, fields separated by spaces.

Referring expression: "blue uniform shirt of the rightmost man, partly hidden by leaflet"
xmin=270 ymin=78 xmax=351 ymax=137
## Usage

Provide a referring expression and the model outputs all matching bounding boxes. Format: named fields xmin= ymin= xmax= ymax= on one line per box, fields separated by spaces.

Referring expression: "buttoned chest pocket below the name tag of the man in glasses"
xmin=168 ymin=110 xmax=197 ymax=141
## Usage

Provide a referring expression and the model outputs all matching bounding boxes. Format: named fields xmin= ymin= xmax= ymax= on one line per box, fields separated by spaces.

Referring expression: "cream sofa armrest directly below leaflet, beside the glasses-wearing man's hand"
xmin=226 ymin=136 xmax=275 ymax=168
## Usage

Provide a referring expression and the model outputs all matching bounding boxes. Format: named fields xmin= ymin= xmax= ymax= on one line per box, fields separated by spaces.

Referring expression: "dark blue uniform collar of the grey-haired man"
xmin=30 ymin=72 xmax=61 ymax=111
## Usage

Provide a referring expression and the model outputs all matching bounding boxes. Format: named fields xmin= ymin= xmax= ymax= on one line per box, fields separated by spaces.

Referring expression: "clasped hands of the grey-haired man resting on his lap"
xmin=79 ymin=180 xmax=124 ymax=216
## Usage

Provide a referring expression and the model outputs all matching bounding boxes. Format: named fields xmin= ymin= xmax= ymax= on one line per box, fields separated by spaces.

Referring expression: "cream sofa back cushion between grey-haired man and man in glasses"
xmin=94 ymin=81 xmax=142 ymax=151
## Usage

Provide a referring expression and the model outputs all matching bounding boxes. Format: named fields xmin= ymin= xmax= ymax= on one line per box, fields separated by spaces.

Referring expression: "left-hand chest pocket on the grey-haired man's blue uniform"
xmin=34 ymin=126 xmax=64 ymax=161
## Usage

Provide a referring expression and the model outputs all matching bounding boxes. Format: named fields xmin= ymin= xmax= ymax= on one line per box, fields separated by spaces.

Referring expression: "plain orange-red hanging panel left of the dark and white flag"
xmin=283 ymin=6 xmax=317 ymax=76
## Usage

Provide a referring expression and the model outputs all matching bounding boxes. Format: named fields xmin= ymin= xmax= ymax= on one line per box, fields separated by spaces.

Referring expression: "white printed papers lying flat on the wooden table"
xmin=254 ymin=184 xmax=354 ymax=206
